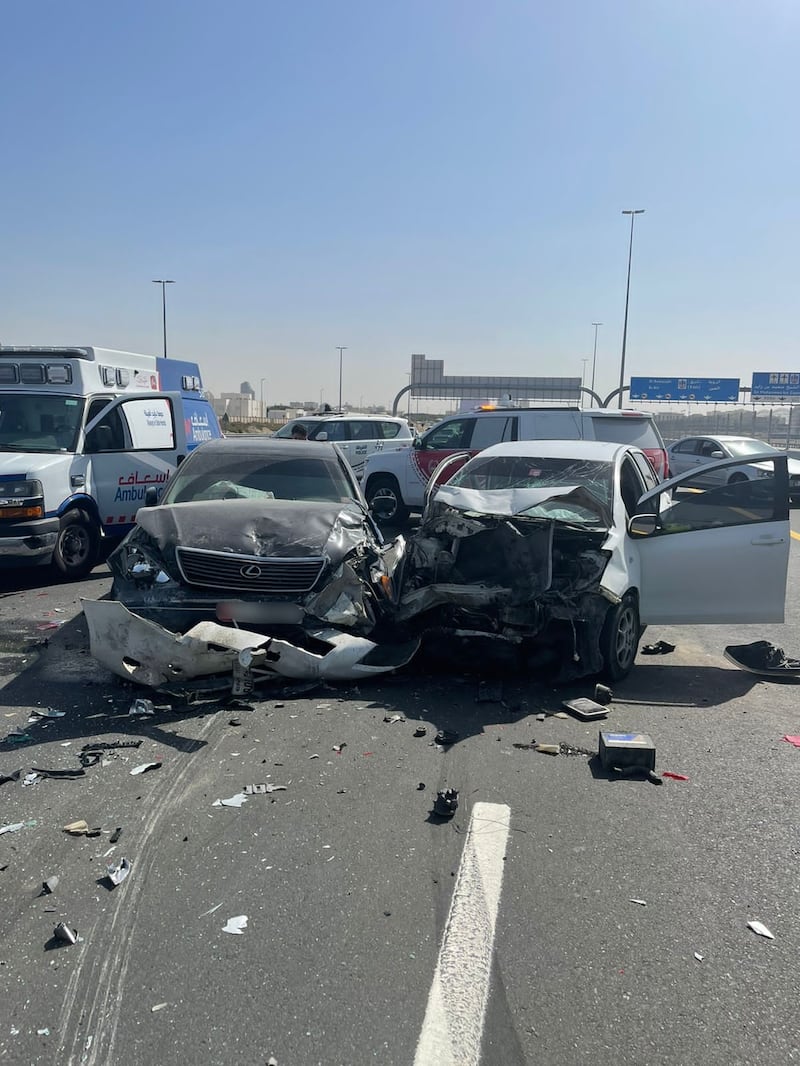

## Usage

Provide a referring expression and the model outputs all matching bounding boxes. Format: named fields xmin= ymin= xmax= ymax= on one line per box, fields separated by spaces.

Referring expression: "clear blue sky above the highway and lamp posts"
xmin=0 ymin=0 xmax=800 ymax=404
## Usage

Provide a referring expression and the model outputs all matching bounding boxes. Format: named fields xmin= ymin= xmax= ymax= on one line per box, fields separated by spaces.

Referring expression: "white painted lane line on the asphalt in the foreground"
xmin=414 ymin=803 xmax=511 ymax=1066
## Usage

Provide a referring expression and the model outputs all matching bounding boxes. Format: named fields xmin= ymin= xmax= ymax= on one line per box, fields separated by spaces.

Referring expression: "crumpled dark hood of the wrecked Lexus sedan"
xmin=137 ymin=500 xmax=364 ymax=563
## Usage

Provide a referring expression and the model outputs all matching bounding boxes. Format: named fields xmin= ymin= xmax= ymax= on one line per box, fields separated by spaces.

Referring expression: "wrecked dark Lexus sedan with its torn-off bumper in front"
xmin=84 ymin=437 xmax=415 ymax=685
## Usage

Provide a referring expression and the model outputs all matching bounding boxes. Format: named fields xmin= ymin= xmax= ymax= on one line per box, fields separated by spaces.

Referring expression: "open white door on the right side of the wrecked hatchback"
xmin=628 ymin=454 xmax=790 ymax=625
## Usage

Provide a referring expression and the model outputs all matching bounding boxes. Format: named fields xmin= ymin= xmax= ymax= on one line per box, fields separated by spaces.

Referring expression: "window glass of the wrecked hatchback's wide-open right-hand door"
xmin=659 ymin=461 xmax=788 ymax=533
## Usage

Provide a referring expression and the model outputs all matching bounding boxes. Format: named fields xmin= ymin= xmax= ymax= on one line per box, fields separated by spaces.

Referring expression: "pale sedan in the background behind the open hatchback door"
xmin=667 ymin=435 xmax=800 ymax=501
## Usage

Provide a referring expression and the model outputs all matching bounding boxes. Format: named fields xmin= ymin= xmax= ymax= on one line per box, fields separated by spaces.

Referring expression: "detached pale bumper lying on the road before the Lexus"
xmin=82 ymin=600 xmax=419 ymax=689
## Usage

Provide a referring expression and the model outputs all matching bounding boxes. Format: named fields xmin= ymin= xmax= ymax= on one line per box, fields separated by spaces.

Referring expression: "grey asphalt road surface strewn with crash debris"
xmin=0 ymin=513 xmax=800 ymax=1066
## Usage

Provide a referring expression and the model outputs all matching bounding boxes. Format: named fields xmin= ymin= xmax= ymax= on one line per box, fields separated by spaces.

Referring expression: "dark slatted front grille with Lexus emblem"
xmin=176 ymin=548 xmax=324 ymax=594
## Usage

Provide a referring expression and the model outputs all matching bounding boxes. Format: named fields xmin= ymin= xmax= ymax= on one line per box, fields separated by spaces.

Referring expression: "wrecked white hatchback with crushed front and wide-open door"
xmin=403 ymin=440 xmax=789 ymax=681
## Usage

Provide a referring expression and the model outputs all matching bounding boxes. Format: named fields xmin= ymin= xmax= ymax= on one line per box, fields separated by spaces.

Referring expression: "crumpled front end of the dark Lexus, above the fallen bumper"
xmin=109 ymin=500 xmax=405 ymax=636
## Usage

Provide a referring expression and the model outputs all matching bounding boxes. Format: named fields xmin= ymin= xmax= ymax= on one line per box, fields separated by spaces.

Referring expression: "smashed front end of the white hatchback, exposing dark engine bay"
xmin=398 ymin=461 xmax=625 ymax=681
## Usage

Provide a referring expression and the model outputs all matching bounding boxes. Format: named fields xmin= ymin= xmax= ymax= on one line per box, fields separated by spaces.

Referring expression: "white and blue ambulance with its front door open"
xmin=0 ymin=345 xmax=222 ymax=580
